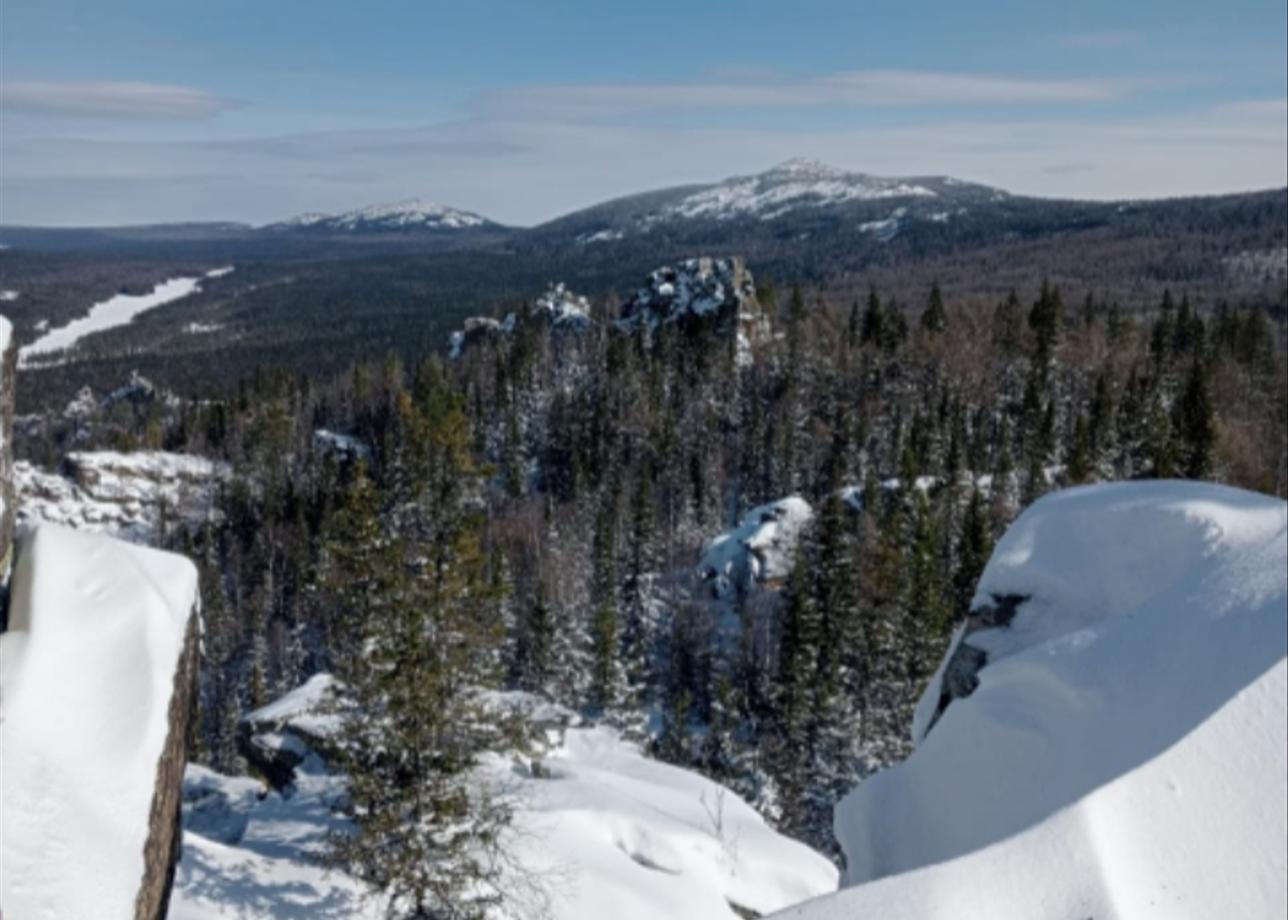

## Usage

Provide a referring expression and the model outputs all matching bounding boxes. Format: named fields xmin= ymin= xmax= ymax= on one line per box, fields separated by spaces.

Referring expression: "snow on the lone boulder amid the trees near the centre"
xmin=698 ymin=495 xmax=814 ymax=598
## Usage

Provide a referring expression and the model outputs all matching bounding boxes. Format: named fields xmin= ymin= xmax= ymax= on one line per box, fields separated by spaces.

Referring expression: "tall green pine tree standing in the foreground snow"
xmin=331 ymin=391 xmax=510 ymax=920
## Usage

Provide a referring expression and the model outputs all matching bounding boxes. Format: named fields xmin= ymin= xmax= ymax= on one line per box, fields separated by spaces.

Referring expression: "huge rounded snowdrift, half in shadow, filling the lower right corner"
xmin=784 ymin=482 xmax=1288 ymax=920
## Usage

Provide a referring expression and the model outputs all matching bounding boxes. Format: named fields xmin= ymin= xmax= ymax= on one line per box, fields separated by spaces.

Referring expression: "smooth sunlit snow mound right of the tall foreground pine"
xmin=495 ymin=727 xmax=836 ymax=920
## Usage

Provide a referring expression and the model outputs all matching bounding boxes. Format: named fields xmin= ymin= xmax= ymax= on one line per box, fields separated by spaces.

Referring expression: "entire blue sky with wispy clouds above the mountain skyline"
xmin=0 ymin=0 xmax=1288 ymax=224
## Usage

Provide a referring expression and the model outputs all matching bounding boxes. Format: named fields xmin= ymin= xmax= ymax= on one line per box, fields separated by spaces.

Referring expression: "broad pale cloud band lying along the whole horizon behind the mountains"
xmin=0 ymin=99 xmax=1288 ymax=224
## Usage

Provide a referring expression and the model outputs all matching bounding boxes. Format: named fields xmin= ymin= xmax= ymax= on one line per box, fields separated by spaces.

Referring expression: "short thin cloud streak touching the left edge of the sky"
xmin=0 ymin=82 xmax=237 ymax=119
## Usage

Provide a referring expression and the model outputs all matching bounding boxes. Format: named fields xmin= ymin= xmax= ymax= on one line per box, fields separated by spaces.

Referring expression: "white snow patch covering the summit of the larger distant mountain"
xmin=645 ymin=158 xmax=935 ymax=223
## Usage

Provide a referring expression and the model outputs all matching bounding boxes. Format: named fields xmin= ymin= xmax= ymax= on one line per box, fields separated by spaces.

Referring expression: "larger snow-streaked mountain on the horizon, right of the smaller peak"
xmin=538 ymin=158 xmax=1014 ymax=242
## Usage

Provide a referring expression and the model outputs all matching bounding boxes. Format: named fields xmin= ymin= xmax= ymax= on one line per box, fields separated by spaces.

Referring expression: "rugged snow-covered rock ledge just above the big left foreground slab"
xmin=14 ymin=451 xmax=231 ymax=542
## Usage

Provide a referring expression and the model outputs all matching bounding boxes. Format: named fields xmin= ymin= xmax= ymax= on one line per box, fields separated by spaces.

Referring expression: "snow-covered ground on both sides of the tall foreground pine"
xmin=170 ymin=676 xmax=836 ymax=920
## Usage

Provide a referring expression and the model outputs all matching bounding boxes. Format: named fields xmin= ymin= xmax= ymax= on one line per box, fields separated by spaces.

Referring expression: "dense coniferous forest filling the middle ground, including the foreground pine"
xmin=22 ymin=260 xmax=1288 ymax=916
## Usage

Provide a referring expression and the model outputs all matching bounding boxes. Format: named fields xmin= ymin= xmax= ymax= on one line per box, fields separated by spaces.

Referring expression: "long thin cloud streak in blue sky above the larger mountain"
xmin=470 ymin=70 xmax=1151 ymax=121
